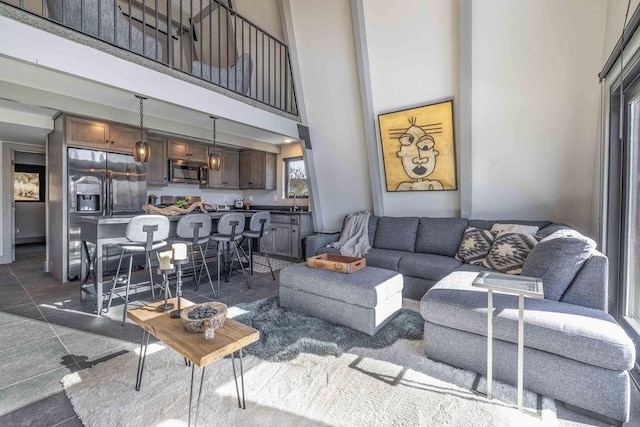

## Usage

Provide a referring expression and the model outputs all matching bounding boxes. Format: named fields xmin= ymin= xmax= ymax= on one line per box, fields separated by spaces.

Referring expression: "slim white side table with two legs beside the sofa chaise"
xmin=472 ymin=271 xmax=544 ymax=410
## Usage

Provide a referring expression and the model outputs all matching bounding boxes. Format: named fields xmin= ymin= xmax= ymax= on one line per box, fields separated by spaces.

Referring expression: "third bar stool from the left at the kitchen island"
xmin=210 ymin=213 xmax=251 ymax=295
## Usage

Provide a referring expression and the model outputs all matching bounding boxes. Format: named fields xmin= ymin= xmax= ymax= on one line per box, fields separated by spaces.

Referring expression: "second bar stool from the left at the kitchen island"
xmin=173 ymin=213 xmax=217 ymax=297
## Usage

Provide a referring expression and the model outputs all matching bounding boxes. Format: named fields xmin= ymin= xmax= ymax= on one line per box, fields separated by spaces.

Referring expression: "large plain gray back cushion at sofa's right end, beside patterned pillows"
xmin=522 ymin=230 xmax=596 ymax=301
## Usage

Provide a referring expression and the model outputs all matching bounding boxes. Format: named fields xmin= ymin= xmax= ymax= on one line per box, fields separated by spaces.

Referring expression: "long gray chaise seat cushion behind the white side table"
xmin=420 ymin=272 xmax=635 ymax=370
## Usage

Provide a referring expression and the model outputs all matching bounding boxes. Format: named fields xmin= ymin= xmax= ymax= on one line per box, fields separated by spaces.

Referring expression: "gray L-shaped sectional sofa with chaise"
xmin=306 ymin=216 xmax=636 ymax=421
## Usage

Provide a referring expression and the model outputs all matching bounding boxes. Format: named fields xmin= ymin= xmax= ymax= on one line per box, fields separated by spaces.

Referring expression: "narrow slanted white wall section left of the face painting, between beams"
xmin=291 ymin=0 xmax=372 ymax=230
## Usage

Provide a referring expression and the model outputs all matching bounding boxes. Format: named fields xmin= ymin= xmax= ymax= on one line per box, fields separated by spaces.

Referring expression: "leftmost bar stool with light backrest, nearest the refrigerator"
xmin=106 ymin=215 xmax=169 ymax=326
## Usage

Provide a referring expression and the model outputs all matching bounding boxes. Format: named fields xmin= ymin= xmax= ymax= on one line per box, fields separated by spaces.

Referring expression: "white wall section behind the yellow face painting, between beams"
xmin=363 ymin=0 xmax=460 ymax=216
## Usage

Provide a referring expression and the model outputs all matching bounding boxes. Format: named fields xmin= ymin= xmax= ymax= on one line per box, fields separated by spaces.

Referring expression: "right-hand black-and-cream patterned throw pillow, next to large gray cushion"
xmin=483 ymin=232 xmax=540 ymax=274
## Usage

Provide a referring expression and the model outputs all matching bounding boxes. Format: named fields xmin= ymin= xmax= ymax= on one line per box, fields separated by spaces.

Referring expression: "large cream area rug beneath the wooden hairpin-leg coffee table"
xmin=62 ymin=299 xmax=556 ymax=427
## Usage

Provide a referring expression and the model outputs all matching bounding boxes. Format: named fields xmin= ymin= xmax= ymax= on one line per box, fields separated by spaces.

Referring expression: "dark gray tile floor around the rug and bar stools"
xmin=0 ymin=245 xmax=640 ymax=427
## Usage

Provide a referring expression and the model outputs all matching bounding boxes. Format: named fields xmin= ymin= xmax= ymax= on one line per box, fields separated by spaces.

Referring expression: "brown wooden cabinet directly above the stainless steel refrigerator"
xmin=66 ymin=116 xmax=140 ymax=154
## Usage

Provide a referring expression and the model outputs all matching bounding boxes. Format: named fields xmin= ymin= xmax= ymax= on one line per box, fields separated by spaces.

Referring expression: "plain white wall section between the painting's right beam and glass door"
xmin=471 ymin=0 xmax=606 ymax=235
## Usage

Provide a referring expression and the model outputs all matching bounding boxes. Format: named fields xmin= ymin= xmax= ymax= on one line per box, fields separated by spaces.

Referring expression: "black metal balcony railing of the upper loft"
xmin=0 ymin=0 xmax=298 ymax=116
